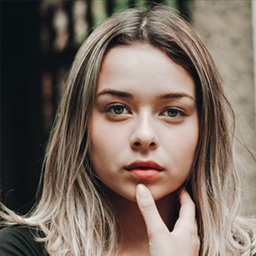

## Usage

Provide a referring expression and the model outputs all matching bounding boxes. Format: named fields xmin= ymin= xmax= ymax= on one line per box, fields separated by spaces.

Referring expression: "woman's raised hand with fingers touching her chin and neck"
xmin=136 ymin=184 xmax=200 ymax=256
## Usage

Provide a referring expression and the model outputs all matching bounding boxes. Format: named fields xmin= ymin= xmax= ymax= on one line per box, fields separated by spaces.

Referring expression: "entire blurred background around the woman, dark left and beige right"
xmin=0 ymin=0 xmax=256 ymax=215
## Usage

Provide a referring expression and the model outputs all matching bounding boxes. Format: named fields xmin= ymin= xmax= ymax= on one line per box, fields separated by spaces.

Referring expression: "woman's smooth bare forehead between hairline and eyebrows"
xmin=97 ymin=44 xmax=195 ymax=97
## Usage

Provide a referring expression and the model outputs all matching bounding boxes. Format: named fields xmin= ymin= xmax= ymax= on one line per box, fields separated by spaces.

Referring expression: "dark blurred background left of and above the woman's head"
xmin=0 ymin=0 xmax=190 ymax=213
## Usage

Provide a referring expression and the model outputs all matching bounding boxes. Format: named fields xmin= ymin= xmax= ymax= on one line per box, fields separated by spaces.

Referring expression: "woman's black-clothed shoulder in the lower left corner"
xmin=0 ymin=225 xmax=48 ymax=256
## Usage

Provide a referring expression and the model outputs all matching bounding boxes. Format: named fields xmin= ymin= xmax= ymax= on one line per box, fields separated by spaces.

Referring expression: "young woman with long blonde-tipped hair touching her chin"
xmin=1 ymin=7 xmax=256 ymax=256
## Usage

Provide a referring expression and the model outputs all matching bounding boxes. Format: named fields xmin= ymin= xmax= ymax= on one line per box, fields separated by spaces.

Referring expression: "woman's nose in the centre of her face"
xmin=130 ymin=119 xmax=159 ymax=151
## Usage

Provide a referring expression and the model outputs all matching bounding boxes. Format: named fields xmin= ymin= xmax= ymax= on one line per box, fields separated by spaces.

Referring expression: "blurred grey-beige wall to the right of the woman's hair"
xmin=192 ymin=0 xmax=256 ymax=215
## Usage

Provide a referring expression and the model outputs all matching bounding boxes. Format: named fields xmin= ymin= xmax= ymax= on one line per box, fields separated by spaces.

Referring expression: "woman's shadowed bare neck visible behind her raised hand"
xmin=108 ymin=191 xmax=177 ymax=256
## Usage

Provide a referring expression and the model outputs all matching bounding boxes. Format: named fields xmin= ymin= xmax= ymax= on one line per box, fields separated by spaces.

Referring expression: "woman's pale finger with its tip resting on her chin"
xmin=136 ymin=184 xmax=169 ymax=238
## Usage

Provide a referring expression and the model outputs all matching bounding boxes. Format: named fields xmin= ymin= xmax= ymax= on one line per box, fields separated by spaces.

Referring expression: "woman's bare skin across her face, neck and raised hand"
xmin=90 ymin=44 xmax=199 ymax=256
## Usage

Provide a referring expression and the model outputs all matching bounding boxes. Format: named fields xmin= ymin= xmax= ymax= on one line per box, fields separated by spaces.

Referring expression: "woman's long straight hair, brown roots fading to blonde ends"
xmin=2 ymin=7 xmax=256 ymax=256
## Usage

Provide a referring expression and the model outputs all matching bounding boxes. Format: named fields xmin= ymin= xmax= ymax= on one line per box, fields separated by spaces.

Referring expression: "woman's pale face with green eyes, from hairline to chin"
xmin=90 ymin=44 xmax=198 ymax=201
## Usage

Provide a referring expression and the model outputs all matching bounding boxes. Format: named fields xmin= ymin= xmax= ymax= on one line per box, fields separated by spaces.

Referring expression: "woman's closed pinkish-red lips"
xmin=125 ymin=161 xmax=163 ymax=179
